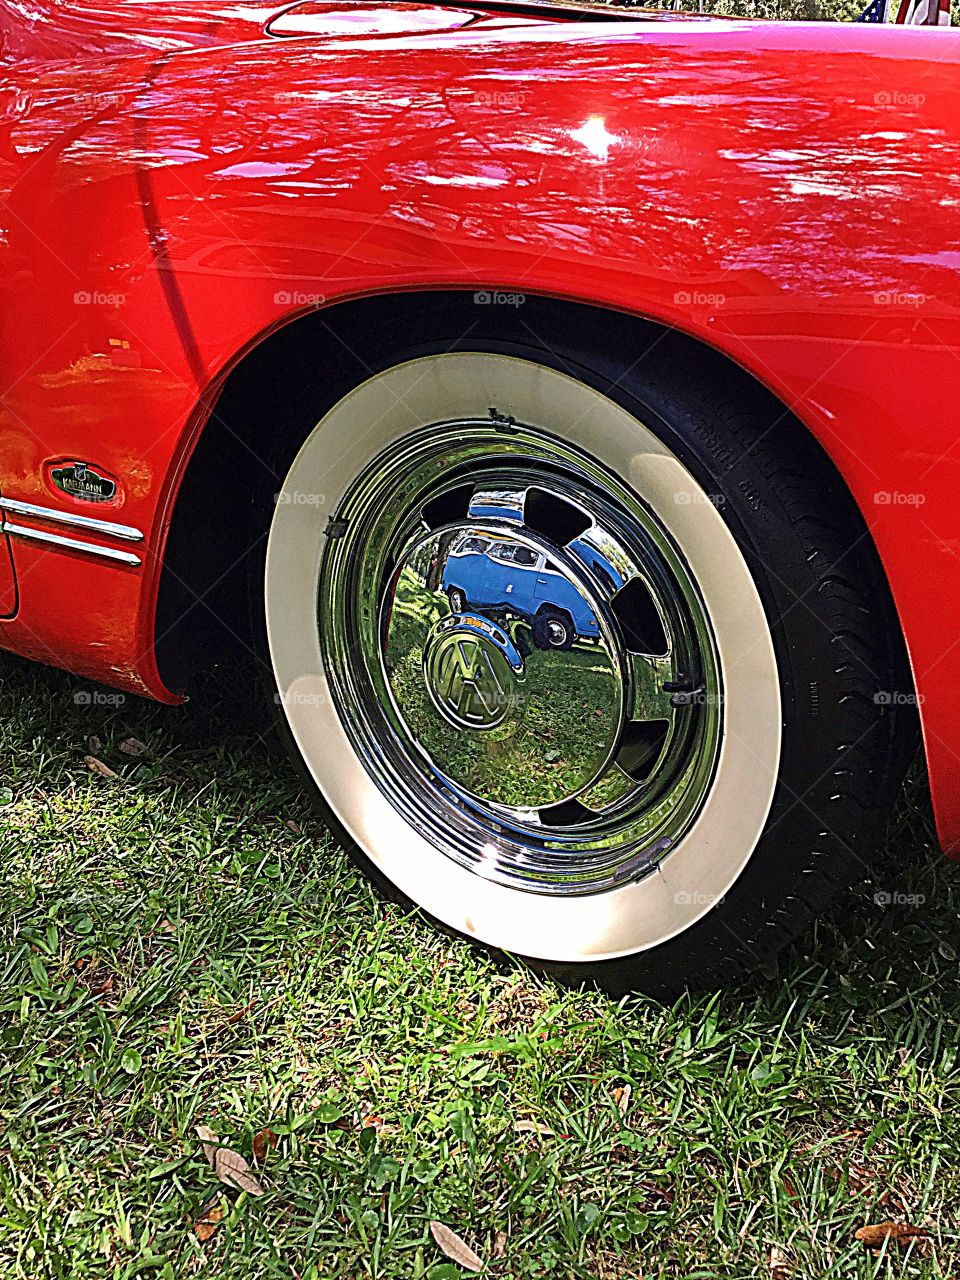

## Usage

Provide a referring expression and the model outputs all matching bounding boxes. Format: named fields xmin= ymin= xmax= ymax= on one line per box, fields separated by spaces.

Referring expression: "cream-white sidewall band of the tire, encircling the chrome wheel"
xmin=265 ymin=353 xmax=781 ymax=961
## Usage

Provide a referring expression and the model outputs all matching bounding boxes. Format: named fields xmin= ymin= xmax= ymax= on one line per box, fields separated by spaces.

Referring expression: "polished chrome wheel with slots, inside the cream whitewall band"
xmin=317 ymin=420 xmax=723 ymax=895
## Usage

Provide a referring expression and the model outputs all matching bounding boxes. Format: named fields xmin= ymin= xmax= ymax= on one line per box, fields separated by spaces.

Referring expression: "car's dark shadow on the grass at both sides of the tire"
xmin=0 ymin=645 xmax=960 ymax=1048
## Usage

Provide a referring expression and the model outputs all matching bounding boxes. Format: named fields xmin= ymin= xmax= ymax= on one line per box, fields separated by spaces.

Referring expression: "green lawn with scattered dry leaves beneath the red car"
xmin=0 ymin=659 xmax=960 ymax=1280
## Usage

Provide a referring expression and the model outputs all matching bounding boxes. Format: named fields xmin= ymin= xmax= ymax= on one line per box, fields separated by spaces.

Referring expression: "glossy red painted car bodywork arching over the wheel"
xmin=0 ymin=0 xmax=960 ymax=851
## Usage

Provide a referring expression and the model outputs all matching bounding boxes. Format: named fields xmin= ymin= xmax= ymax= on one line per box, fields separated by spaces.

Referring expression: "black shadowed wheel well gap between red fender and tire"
xmin=156 ymin=292 xmax=911 ymax=690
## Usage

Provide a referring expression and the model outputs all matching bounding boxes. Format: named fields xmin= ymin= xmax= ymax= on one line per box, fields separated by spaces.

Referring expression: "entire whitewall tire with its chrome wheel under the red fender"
xmin=264 ymin=335 xmax=916 ymax=993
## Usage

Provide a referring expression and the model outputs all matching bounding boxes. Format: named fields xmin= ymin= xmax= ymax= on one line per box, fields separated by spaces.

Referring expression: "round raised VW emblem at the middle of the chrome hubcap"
xmin=424 ymin=630 xmax=513 ymax=730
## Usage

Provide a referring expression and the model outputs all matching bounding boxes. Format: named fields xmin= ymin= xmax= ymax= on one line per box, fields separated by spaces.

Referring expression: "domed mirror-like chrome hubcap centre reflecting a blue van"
xmin=381 ymin=521 xmax=625 ymax=813
